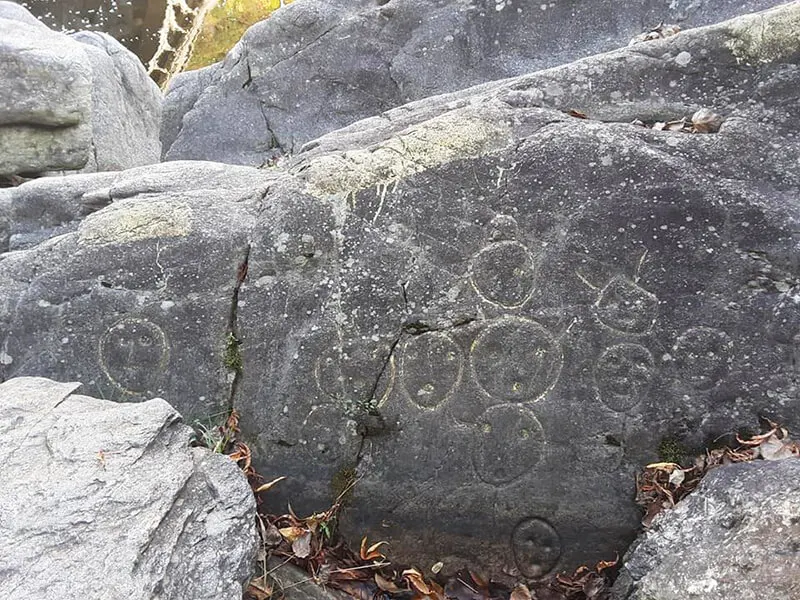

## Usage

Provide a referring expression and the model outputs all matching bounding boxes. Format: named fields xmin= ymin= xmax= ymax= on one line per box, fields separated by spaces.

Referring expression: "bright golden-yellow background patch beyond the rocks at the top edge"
xmin=185 ymin=0 xmax=291 ymax=71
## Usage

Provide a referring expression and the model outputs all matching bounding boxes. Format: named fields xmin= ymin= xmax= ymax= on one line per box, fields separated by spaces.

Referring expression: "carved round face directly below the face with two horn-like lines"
xmin=594 ymin=344 xmax=655 ymax=412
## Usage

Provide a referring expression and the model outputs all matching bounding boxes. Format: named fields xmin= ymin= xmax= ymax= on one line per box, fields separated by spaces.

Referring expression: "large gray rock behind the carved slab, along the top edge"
xmin=162 ymin=0 xmax=779 ymax=166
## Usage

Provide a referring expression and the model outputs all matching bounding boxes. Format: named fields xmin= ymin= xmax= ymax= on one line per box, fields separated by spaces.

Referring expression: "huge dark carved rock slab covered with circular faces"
xmin=0 ymin=2 xmax=800 ymax=578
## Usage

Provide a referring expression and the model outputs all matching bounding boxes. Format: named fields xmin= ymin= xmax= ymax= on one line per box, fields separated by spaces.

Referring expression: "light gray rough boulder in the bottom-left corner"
xmin=0 ymin=378 xmax=256 ymax=600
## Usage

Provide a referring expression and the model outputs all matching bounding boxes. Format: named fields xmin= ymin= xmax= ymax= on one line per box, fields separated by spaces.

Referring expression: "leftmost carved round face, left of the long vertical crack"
xmin=99 ymin=317 xmax=169 ymax=394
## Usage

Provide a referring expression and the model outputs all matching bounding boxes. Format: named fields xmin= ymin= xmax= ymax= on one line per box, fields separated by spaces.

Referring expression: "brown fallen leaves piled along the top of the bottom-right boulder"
xmin=636 ymin=421 xmax=800 ymax=527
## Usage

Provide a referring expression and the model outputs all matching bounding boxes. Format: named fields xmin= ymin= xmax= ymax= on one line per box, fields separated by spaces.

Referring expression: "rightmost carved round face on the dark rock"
xmin=672 ymin=327 xmax=733 ymax=390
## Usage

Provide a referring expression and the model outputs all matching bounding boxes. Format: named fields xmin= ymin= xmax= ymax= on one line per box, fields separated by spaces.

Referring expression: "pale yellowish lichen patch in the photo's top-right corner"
xmin=726 ymin=3 xmax=800 ymax=64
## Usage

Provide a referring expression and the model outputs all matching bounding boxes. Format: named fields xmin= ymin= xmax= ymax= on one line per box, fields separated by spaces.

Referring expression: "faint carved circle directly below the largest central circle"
xmin=472 ymin=404 xmax=544 ymax=485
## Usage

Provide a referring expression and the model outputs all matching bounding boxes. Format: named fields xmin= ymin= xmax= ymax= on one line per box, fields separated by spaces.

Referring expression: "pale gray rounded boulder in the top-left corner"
xmin=0 ymin=3 xmax=162 ymax=175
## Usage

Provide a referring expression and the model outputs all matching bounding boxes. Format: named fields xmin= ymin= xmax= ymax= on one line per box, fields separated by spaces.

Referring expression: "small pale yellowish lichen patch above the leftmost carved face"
xmin=78 ymin=200 xmax=192 ymax=246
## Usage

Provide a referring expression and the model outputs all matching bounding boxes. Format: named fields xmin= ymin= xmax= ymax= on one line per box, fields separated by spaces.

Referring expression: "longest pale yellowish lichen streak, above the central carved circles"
xmin=302 ymin=110 xmax=511 ymax=197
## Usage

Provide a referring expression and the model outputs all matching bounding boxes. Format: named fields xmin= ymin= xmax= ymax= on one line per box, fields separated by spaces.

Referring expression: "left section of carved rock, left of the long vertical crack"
xmin=0 ymin=162 xmax=269 ymax=420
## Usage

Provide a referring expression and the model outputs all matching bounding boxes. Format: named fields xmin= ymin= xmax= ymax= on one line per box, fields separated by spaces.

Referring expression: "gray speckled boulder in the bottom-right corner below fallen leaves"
xmin=614 ymin=459 xmax=800 ymax=600
